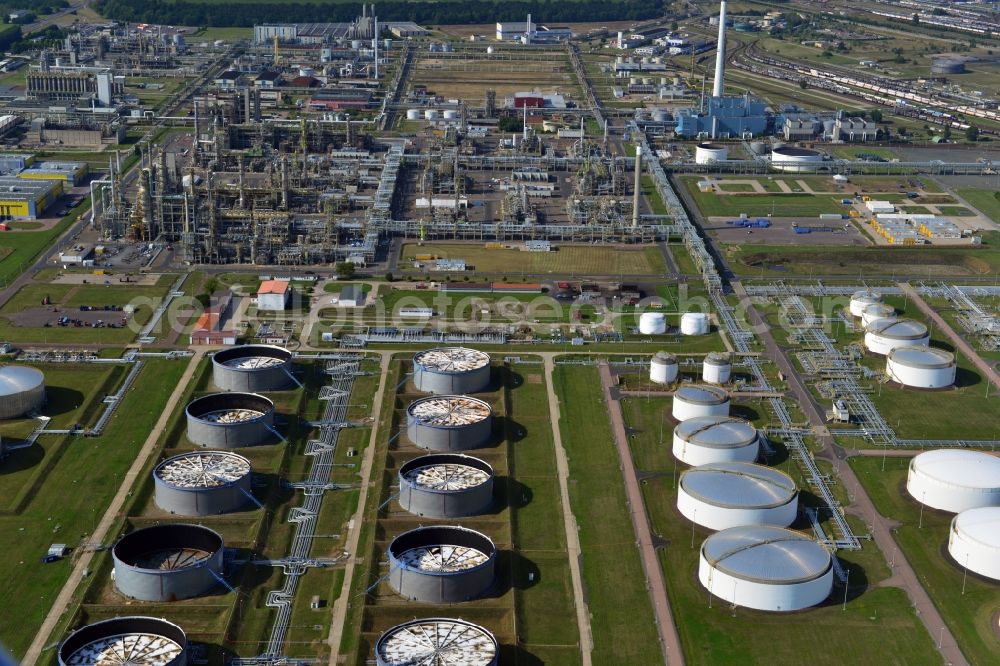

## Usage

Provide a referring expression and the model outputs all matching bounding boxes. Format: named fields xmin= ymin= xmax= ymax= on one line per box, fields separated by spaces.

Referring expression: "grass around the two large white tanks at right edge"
xmin=849 ymin=457 xmax=1000 ymax=666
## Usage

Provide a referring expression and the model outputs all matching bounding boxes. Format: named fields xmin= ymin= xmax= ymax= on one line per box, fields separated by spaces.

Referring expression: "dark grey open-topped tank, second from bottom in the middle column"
xmin=388 ymin=525 xmax=497 ymax=604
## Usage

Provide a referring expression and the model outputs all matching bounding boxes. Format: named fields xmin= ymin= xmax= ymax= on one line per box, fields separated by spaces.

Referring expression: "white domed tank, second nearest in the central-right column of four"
xmin=677 ymin=462 xmax=799 ymax=530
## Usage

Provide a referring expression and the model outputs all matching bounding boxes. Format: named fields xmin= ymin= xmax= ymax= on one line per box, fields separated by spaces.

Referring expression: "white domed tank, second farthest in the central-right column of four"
xmin=673 ymin=416 xmax=760 ymax=467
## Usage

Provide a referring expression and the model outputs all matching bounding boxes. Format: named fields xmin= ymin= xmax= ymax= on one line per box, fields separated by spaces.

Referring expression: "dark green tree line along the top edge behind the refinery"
xmin=93 ymin=0 xmax=663 ymax=27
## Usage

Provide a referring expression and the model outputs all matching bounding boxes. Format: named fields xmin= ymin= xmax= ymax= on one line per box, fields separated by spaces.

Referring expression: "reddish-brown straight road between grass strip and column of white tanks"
xmin=598 ymin=362 xmax=684 ymax=666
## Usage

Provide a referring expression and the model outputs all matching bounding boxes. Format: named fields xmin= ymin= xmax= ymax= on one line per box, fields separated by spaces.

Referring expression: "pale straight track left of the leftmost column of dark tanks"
xmin=21 ymin=351 xmax=205 ymax=666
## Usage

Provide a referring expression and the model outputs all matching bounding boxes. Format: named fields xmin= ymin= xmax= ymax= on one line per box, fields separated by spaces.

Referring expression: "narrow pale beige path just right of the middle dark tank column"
xmin=544 ymin=354 xmax=594 ymax=666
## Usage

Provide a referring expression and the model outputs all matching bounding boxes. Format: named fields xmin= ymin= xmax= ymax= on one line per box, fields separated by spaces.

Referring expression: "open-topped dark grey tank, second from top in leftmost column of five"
xmin=185 ymin=392 xmax=274 ymax=449
